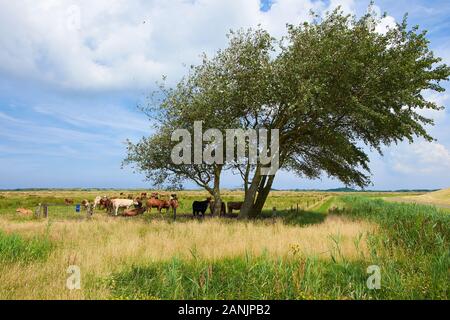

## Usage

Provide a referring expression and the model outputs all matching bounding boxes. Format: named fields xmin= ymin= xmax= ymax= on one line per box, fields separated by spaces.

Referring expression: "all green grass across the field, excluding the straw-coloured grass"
xmin=0 ymin=192 xmax=450 ymax=300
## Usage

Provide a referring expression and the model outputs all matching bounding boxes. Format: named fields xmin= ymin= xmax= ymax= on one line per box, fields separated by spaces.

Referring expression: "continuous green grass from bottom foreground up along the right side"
xmin=106 ymin=196 xmax=450 ymax=299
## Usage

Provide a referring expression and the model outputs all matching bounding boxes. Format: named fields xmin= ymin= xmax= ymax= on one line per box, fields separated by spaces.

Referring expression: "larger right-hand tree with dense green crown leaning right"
xmin=241 ymin=9 xmax=450 ymax=216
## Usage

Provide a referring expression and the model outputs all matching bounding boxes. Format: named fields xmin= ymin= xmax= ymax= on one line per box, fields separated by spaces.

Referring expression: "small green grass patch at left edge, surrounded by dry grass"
xmin=0 ymin=230 xmax=53 ymax=264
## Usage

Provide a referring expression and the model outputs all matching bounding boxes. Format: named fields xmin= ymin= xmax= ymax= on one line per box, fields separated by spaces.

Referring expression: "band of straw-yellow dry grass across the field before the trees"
xmin=0 ymin=215 xmax=375 ymax=299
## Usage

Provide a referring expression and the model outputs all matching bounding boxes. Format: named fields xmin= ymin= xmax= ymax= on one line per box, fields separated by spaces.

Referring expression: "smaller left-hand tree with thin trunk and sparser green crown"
xmin=124 ymin=30 xmax=273 ymax=213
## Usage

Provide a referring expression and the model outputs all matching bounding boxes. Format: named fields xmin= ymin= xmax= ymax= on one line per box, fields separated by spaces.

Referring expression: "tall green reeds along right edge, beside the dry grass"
xmin=342 ymin=197 xmax=450 ymax=299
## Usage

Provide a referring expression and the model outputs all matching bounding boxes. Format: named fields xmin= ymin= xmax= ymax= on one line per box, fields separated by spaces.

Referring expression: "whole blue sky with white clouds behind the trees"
xmin=0 ymin=0 xmax=450 ymax=190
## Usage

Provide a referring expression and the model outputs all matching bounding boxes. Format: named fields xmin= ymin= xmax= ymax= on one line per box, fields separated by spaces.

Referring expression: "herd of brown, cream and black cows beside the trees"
xmin=73 ymin=192 xmax=243 ymax=217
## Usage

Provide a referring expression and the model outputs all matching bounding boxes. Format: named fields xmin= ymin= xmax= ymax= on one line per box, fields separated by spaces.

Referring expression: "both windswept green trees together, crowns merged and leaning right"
xmin=127 ymin=9 xmax=450 ymax=217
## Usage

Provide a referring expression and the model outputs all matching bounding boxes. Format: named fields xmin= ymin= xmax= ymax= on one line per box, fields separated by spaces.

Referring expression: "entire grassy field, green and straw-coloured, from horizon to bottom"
xmin=0 ymin=190 xmax=450 ymax=299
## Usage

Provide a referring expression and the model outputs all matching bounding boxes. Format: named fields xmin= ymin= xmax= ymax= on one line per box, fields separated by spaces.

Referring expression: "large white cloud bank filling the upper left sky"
xmin=0 ymin=0 xmax=366 ymax=90
